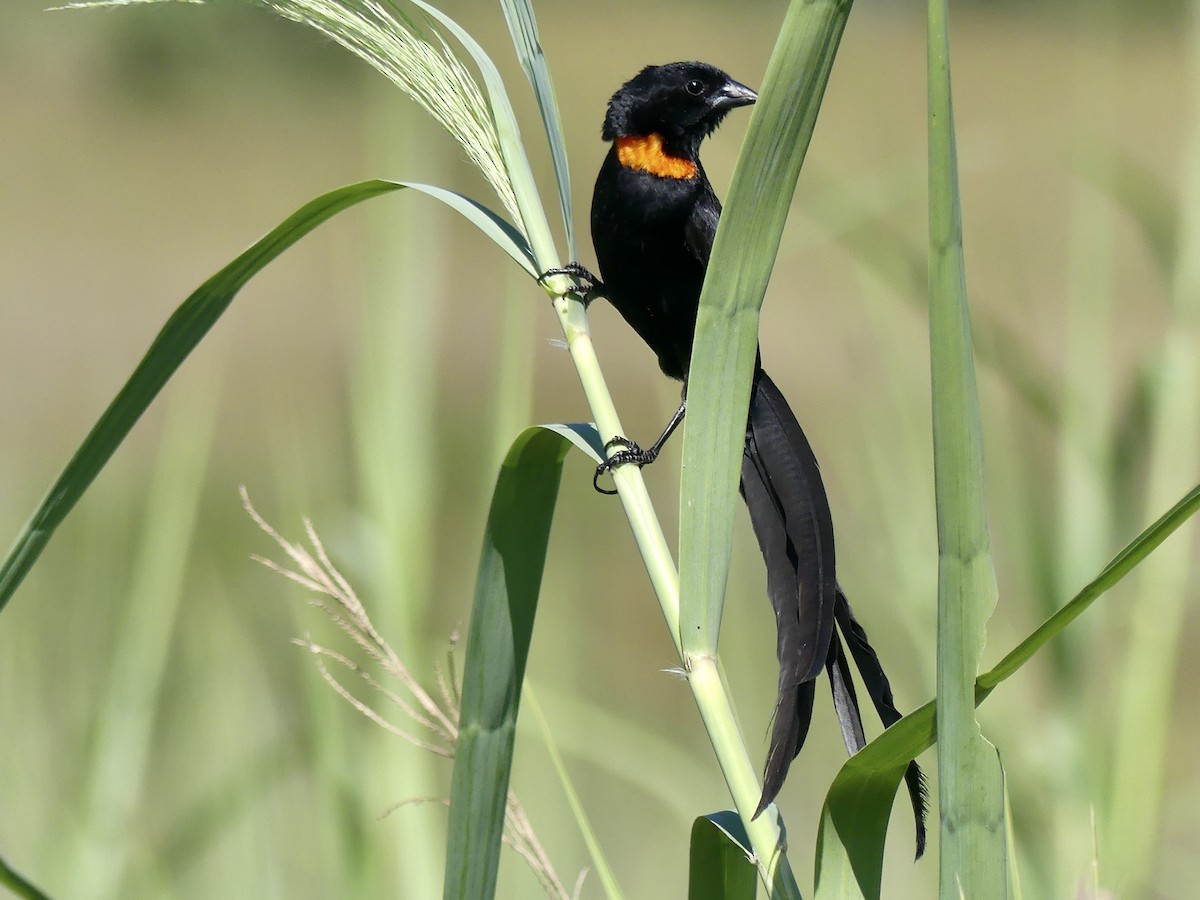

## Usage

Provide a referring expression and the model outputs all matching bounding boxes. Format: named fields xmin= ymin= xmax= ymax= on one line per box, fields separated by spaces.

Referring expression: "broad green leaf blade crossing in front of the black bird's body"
xmin=679 ymin=0 xmax=851 ymax=662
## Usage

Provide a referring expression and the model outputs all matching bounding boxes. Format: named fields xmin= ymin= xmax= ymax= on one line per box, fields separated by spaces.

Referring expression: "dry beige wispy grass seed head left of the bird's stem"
xmin=241 ymin=487 xmax=587 ymax=900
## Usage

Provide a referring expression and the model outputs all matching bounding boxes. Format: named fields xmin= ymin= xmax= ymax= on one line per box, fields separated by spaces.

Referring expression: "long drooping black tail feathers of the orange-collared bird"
xmin=742 ymin=368 xmax=925 ymax=857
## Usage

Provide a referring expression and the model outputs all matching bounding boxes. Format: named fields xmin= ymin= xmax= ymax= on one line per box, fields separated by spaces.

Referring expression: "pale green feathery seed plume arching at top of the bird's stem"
xmin=55 ymin=0 xmax=526 ymax=234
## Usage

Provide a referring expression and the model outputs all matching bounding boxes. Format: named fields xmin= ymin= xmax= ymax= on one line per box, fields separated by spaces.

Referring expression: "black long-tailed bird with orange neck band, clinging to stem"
xmin=556 ymin=62 xmax=925 ymax=857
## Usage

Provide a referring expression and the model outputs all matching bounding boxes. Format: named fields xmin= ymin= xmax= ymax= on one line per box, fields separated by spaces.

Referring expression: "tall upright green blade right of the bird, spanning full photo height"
xmin=929 ymin=0 xmax=1007 ymax=900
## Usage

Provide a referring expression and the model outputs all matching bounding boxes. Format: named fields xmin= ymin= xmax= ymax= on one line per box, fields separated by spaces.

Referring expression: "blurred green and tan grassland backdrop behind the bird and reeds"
xmin=0 ymin=0 xmax=1200 ymax=898
